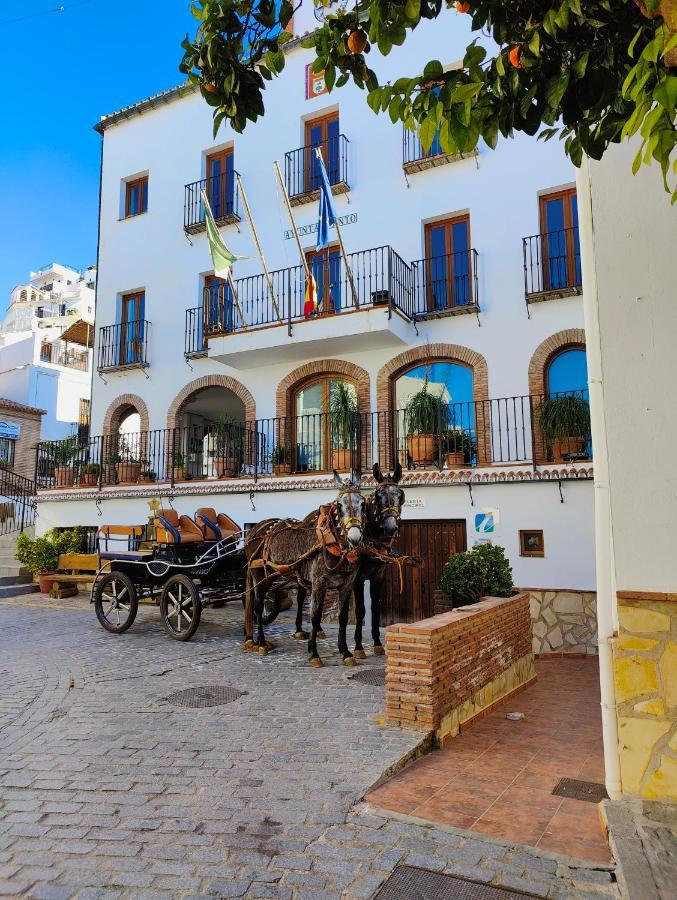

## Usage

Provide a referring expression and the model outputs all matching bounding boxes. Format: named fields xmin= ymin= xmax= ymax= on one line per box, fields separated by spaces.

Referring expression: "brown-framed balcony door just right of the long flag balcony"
xmin=423 ymin=216 xmax=473 ymax=312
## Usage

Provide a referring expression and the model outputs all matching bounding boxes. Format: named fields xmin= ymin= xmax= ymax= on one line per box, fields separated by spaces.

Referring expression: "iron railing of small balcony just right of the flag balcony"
xmin=411 ymin=249 xmax=479 ymax=319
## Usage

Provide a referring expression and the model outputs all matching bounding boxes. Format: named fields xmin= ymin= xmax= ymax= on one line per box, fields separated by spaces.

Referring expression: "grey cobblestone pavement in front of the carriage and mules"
xmin=0 ymin=598 xmax=616 ymax=900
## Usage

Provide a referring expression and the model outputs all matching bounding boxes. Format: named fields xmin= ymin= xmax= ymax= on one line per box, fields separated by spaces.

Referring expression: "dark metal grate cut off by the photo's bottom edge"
xmin=376 ymin=866 xmax=529 ymax=900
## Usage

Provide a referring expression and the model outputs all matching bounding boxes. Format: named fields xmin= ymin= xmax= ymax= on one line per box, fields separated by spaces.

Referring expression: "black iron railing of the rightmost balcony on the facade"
xmin=522 ymin=225 xmax=582 ymax=299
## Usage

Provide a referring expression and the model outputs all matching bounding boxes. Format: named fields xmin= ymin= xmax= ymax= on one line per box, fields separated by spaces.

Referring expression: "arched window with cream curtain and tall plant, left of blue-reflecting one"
xmin=291 ymin=376 xmax=359 ymax=472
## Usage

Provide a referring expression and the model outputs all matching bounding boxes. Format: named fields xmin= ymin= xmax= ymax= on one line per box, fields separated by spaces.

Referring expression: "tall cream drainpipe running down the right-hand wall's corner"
xmin=576 ymin=157 xmax=621 ymax=800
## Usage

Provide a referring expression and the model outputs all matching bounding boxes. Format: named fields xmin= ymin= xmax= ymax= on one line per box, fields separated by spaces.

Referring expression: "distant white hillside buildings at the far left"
xmin=0 ymin=263 xmax=96 ymax=440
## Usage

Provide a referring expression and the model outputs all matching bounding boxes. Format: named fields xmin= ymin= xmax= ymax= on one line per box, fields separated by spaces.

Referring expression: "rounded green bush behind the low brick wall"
xmin=440 ymin=544 xmax=513 ymax=606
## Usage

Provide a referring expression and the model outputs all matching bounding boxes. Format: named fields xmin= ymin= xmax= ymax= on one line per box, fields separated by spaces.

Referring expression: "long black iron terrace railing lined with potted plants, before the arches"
xmin=37 ymin=391 xmax=592 ymax=489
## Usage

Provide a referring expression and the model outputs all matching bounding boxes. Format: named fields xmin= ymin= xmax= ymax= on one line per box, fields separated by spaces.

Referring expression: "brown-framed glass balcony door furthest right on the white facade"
xmin=540 ymin=188 xmax=581 ymax=291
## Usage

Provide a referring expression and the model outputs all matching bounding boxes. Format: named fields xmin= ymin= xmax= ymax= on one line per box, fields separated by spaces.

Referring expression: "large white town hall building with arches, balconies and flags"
xmin=39 ymin=6 xmax=595 ymax=651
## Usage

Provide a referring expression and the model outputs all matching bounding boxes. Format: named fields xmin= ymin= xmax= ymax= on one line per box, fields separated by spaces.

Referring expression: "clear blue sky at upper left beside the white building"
xmin=0 ymin=0 xmax=197 ymax=310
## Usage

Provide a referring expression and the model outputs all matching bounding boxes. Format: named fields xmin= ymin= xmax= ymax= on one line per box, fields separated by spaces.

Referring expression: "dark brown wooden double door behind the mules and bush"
xmin=381 ymin=519 xmax=468 ymax=625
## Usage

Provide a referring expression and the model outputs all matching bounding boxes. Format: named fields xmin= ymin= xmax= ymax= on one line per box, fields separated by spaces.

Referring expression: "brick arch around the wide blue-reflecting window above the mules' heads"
xmin=376 ymin=344 xmax=491 ymax=465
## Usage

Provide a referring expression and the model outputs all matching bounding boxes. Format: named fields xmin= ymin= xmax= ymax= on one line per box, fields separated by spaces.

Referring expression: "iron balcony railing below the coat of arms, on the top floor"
xmin=284 ymin=134 xmax=350 ymax=206
